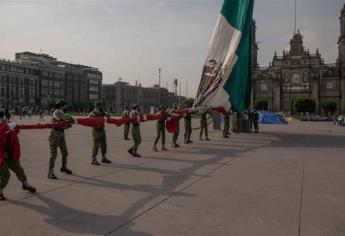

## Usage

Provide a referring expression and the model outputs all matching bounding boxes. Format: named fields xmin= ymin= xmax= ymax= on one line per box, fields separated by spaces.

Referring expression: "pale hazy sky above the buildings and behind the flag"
xmin=0 ymin=0 xmax=344 ymax=97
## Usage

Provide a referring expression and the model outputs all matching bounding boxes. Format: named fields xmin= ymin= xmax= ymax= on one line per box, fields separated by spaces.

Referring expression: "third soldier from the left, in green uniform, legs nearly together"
xmin=89 ymin=101 xmax=111 ymax=165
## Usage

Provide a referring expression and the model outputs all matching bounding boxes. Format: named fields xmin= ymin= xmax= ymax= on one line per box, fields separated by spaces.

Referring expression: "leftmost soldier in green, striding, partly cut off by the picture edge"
xmin=0 ymin=114 xmax=36 ymax=201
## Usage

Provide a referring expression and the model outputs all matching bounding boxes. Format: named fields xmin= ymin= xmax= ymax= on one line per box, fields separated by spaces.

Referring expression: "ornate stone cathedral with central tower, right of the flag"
xmin=252 ymin=5 xmax=345 ymax=114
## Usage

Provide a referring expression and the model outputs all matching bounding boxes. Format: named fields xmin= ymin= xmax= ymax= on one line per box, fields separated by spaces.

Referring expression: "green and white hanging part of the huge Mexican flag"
xmin=194 ymin=0 xmax=254 ymax=112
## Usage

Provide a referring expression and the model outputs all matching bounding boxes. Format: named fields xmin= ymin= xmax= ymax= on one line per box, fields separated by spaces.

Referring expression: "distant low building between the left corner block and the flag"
xmin=102 ymin=80 xmax=179 ymax=113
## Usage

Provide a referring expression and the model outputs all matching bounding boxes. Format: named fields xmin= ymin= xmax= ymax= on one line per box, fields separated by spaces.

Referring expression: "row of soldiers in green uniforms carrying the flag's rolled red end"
xmin=0 ymin=100 xmax=234 ymax=200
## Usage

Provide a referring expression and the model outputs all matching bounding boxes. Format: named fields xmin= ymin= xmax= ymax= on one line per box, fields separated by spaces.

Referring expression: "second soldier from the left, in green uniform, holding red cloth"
xmin=48 ymin=100 xmax=72 ymax=179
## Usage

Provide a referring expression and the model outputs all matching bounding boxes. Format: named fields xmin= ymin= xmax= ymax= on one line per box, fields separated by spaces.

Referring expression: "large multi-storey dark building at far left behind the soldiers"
xmin=0 ymin=52 xmax=102 ymax=106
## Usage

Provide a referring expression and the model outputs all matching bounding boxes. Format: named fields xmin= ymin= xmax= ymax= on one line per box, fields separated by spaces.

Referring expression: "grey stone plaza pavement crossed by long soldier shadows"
xmin=0 ymin=118 xmax=345 ymax=236
